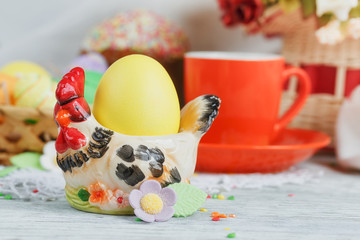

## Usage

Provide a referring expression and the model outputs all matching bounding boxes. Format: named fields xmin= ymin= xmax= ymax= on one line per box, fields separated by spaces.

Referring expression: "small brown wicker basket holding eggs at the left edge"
xmin=0 ymin=106 xmax=58 ymax=165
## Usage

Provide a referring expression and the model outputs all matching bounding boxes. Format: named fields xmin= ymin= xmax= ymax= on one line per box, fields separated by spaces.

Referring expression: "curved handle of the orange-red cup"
xmin=273 ymin=67 xmax=311 ymax=136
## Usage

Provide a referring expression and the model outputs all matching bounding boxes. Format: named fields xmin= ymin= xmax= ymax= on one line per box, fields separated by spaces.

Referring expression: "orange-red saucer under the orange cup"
xmin=196 ymin=129 xmax=330 ymax=173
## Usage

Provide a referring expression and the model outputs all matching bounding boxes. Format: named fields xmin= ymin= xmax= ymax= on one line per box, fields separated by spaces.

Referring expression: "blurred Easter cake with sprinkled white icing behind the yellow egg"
xmin=82 ymin=10 xmax=189 ymax=105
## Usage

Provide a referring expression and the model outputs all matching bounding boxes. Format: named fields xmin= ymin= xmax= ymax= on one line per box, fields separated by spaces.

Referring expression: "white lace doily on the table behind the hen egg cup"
xmin=0 ymin=167 xmax=323 ymax=201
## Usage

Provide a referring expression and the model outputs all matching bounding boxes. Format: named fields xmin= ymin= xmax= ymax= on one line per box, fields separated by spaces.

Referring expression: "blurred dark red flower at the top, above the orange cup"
xmin=218 ymin=0 xmax=264 ymax=26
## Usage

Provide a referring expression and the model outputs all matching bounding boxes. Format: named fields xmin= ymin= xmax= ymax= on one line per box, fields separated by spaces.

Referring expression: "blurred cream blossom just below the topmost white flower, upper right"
xmin=315 ymin=20 xmax=344 ymax=45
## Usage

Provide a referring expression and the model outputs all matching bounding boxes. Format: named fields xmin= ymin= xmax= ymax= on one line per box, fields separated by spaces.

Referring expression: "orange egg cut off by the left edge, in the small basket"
xmin=0 ymin=73 xmax=18 ymax=104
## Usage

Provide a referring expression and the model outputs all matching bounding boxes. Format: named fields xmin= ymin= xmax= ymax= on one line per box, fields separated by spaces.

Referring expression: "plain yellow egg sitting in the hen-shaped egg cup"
xmin=93 ymin=54 xmax=180 ymax=136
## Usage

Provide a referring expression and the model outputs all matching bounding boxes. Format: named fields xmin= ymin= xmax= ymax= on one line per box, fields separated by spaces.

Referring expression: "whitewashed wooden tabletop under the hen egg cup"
xmin=0 ymin=157 xmax=360 ymax=240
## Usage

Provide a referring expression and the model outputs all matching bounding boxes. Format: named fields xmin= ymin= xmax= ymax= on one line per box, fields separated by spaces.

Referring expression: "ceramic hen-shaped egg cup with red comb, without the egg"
xmin=54 ymin=67 xmax=220 ymax=215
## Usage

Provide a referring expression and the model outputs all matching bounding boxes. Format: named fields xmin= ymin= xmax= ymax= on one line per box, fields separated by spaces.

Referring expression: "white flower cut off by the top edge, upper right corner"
xmin=316 ymin=0 xmax=358 ymax=21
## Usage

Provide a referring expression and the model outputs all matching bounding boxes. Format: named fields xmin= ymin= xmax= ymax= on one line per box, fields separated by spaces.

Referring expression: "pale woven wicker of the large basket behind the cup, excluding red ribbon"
xmin=256 ymin=8 xmax=360 ymax=146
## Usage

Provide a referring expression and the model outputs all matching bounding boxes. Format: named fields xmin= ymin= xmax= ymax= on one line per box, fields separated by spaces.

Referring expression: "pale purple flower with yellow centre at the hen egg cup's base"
xmin=129 ymin=180 xmax=177 ymax=222
